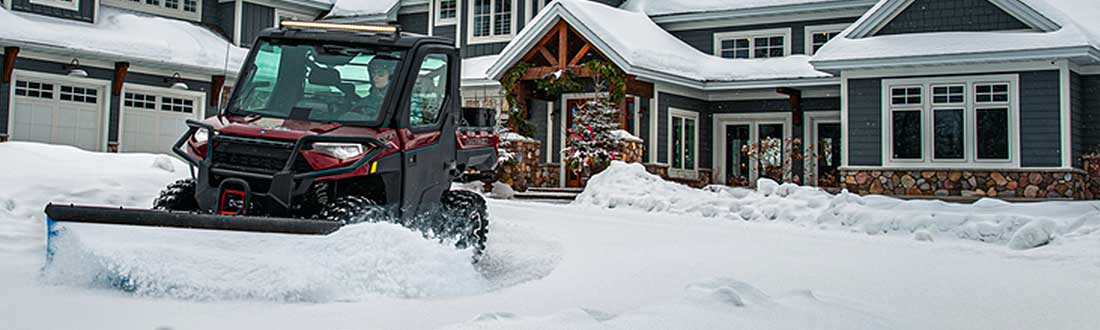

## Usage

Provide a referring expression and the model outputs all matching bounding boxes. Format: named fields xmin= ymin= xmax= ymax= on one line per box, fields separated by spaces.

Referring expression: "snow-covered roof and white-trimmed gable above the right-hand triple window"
xmin=813 ymin=0 xmax=1100 ymax=70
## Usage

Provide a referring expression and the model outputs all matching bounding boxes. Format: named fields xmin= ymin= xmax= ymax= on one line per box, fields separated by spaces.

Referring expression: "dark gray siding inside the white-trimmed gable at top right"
xmin=878 ymin=0 xmax=1029 ymax=35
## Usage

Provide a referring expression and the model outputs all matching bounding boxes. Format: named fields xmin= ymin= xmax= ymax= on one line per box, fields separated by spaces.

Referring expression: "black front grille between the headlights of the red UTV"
xmin=211 ymin=135 xmax=314 ymax=175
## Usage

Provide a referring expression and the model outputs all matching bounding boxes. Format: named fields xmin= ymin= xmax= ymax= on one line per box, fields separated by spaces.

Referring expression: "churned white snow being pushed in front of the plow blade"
xmin=43 ymin=218 xmax=490 ymax=303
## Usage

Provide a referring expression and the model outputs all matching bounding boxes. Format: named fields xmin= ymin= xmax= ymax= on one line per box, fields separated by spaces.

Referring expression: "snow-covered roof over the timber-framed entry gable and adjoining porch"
xmin=488 ymin=0 xmax=832 ymax=89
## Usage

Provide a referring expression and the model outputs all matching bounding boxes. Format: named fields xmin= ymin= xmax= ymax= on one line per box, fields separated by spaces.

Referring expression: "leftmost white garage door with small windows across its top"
xmin=11 ymin=78 xmax=103 ymax=151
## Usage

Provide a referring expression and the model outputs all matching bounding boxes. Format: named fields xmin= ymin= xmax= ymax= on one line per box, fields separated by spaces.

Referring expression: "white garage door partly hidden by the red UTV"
xmin=120 ymin=88 xmax=202 ymax=154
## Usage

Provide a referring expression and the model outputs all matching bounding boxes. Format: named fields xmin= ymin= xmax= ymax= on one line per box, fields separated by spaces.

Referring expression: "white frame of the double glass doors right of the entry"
xmin=712 ymin=112 xmax=794 ymax=186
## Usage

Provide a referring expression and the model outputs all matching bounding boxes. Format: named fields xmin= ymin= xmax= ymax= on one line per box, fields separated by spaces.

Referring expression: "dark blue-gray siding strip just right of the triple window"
xmin=1020 ymin=70 xmax=1062 ymax=167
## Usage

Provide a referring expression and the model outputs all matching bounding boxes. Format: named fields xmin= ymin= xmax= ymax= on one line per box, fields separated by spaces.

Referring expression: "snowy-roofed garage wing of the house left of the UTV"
xmin=0 ymin=0 xmax=331 ymax=153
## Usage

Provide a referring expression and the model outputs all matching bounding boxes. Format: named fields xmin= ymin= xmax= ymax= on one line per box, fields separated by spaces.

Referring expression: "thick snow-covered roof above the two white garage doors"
xmin=0 ymin=7 xmax=248 ymax=75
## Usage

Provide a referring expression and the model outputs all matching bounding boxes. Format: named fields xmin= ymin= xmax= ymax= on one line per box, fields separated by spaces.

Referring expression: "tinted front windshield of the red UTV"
xmin=229 ymin=42 xmax=400 ymax=123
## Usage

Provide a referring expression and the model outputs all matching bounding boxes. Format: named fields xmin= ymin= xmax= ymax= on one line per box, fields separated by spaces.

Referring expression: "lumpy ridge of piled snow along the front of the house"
xmin=574 ymin=162 xmax=1100 ymax=249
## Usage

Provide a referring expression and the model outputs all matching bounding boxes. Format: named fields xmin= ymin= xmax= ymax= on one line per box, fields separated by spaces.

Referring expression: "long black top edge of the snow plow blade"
xmin=46 ymin=205 xmax=343 ymax=237
